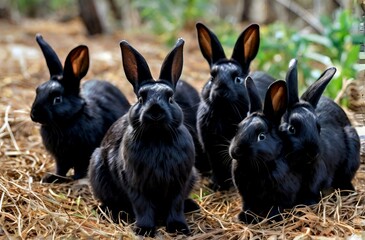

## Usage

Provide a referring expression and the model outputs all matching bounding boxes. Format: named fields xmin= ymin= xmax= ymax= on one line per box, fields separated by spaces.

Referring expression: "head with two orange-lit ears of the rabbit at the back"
xmin=196 ymin=23 xmax=260 ymax=107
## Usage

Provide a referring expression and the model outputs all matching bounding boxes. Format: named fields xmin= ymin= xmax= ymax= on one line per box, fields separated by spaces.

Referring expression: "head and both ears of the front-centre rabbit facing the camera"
xmin=120 ymin=39 xmax=184 ymax=131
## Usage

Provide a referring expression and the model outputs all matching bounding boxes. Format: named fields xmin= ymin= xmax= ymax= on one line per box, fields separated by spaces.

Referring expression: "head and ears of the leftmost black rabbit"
xmin=30 ymin=34 xmax=89 ymax=125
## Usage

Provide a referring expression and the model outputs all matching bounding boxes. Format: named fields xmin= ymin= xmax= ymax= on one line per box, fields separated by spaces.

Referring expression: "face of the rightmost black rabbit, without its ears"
xmin=279 ymin=103 xmax=321 ymax=161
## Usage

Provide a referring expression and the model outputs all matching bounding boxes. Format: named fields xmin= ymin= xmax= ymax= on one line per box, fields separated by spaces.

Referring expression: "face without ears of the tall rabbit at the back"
xmin=202 ymin=61 xmax=246 ymax=102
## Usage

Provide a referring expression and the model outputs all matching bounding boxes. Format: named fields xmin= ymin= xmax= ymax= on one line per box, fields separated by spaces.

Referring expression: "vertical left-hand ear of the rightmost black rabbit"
xmin=285 ymin=59 xmax=299 ymax=107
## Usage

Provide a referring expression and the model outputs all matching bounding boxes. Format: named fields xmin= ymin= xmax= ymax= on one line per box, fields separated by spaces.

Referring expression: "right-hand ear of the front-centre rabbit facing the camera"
xmin=159 ymin=38 xmax=185 ymax=89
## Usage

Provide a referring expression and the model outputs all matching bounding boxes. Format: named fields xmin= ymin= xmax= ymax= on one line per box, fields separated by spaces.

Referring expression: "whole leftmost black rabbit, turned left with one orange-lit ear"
xmin=30 ymin=34 xmax=130 ymax=183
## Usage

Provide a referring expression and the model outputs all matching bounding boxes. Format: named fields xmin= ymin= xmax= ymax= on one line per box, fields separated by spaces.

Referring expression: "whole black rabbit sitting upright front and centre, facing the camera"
xmin=89 ymin=39 xmax=197 ymax=236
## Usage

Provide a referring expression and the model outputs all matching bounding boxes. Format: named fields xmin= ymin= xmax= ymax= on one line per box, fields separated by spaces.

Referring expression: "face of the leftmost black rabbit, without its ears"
xmin=31 ymin=80 xmax=85 ymax=125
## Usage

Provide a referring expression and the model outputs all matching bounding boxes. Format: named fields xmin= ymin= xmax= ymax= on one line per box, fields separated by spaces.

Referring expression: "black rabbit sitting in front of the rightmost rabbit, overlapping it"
xmin=229 ymin=77 xmax=300 ymax=223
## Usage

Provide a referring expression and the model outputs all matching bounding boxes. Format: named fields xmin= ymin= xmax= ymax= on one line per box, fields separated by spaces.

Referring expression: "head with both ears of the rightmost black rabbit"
xmin=280 ymin=59 xmax=336 ymax=161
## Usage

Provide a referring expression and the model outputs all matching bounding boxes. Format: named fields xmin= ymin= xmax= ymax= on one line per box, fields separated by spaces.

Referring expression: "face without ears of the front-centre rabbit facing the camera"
xmin=130 ymin=82 xmax=183 ymax=131
